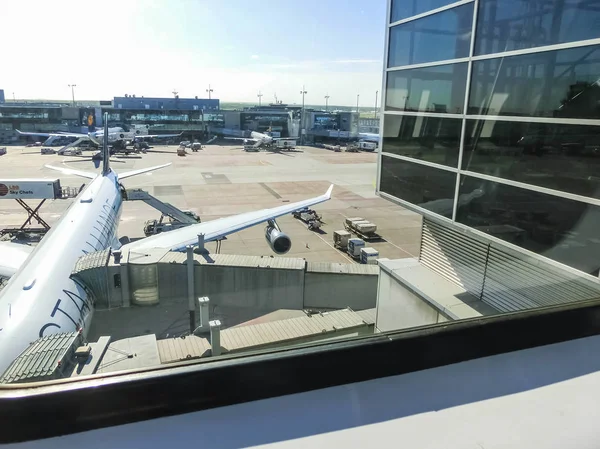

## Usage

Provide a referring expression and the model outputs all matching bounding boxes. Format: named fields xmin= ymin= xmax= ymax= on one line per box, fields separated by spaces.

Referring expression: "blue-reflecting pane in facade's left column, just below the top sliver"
xmin=388 ymin=3 xmax=473 ymax=67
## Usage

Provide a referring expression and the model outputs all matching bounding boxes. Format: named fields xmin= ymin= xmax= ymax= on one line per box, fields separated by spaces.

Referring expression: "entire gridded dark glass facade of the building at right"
xmin=378 ymin=0 xmax=600 ymax=274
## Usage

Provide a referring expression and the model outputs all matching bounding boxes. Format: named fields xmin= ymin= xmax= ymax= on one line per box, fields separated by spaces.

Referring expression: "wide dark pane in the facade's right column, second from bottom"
xmin=464 ymin=119 xmax=600 ymax=198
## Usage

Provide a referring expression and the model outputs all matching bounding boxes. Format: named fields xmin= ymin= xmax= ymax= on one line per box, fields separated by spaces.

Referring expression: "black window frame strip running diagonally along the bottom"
xmin=0 ymin=301 xmax=600 ymax=443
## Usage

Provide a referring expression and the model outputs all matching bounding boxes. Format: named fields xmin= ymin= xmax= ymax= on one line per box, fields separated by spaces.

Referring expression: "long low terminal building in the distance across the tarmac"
xmin=0 ymin=95 xmax=359 ymax=144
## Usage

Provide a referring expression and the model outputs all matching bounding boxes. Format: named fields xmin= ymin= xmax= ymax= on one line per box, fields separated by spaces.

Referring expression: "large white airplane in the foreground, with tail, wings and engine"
xmin=0 ymin=114 xmax=333 ymax=375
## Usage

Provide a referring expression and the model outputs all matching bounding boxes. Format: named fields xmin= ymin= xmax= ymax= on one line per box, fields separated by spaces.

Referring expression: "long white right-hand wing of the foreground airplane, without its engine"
xmin=122 ymin=184 xmax=333 ymax=251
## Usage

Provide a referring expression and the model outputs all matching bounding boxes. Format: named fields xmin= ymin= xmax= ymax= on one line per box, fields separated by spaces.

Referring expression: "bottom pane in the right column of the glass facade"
xmin=456 ymin=176 xmax=600 ymax=273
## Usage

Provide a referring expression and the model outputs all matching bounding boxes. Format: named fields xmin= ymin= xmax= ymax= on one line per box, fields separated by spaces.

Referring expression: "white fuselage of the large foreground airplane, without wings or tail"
xmin=0 ymin=171 xmax=122 ymax=374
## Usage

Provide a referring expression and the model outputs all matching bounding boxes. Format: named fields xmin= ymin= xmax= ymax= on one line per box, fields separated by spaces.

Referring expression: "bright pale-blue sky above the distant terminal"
xmin=0 ymin=0 xmax=386 ymax=106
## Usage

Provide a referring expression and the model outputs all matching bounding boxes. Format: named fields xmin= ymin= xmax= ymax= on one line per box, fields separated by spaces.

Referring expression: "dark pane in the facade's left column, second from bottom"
xmin=383 ymin=115 xmax=462 ymax=168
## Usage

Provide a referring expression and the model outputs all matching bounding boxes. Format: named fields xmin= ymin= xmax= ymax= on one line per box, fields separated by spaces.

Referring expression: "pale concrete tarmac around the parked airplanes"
xmin=0 ymin=145 xmax=421 ymax=263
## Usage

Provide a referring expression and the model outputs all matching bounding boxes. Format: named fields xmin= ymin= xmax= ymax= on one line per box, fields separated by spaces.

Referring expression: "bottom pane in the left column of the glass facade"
xmin=380 ymin=156 xmax=456 ymax=218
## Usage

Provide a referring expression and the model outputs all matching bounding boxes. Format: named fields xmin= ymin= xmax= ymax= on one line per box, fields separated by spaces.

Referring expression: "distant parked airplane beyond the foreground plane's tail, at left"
xmin=16 ymin=125 xmax=181 ymax=154
